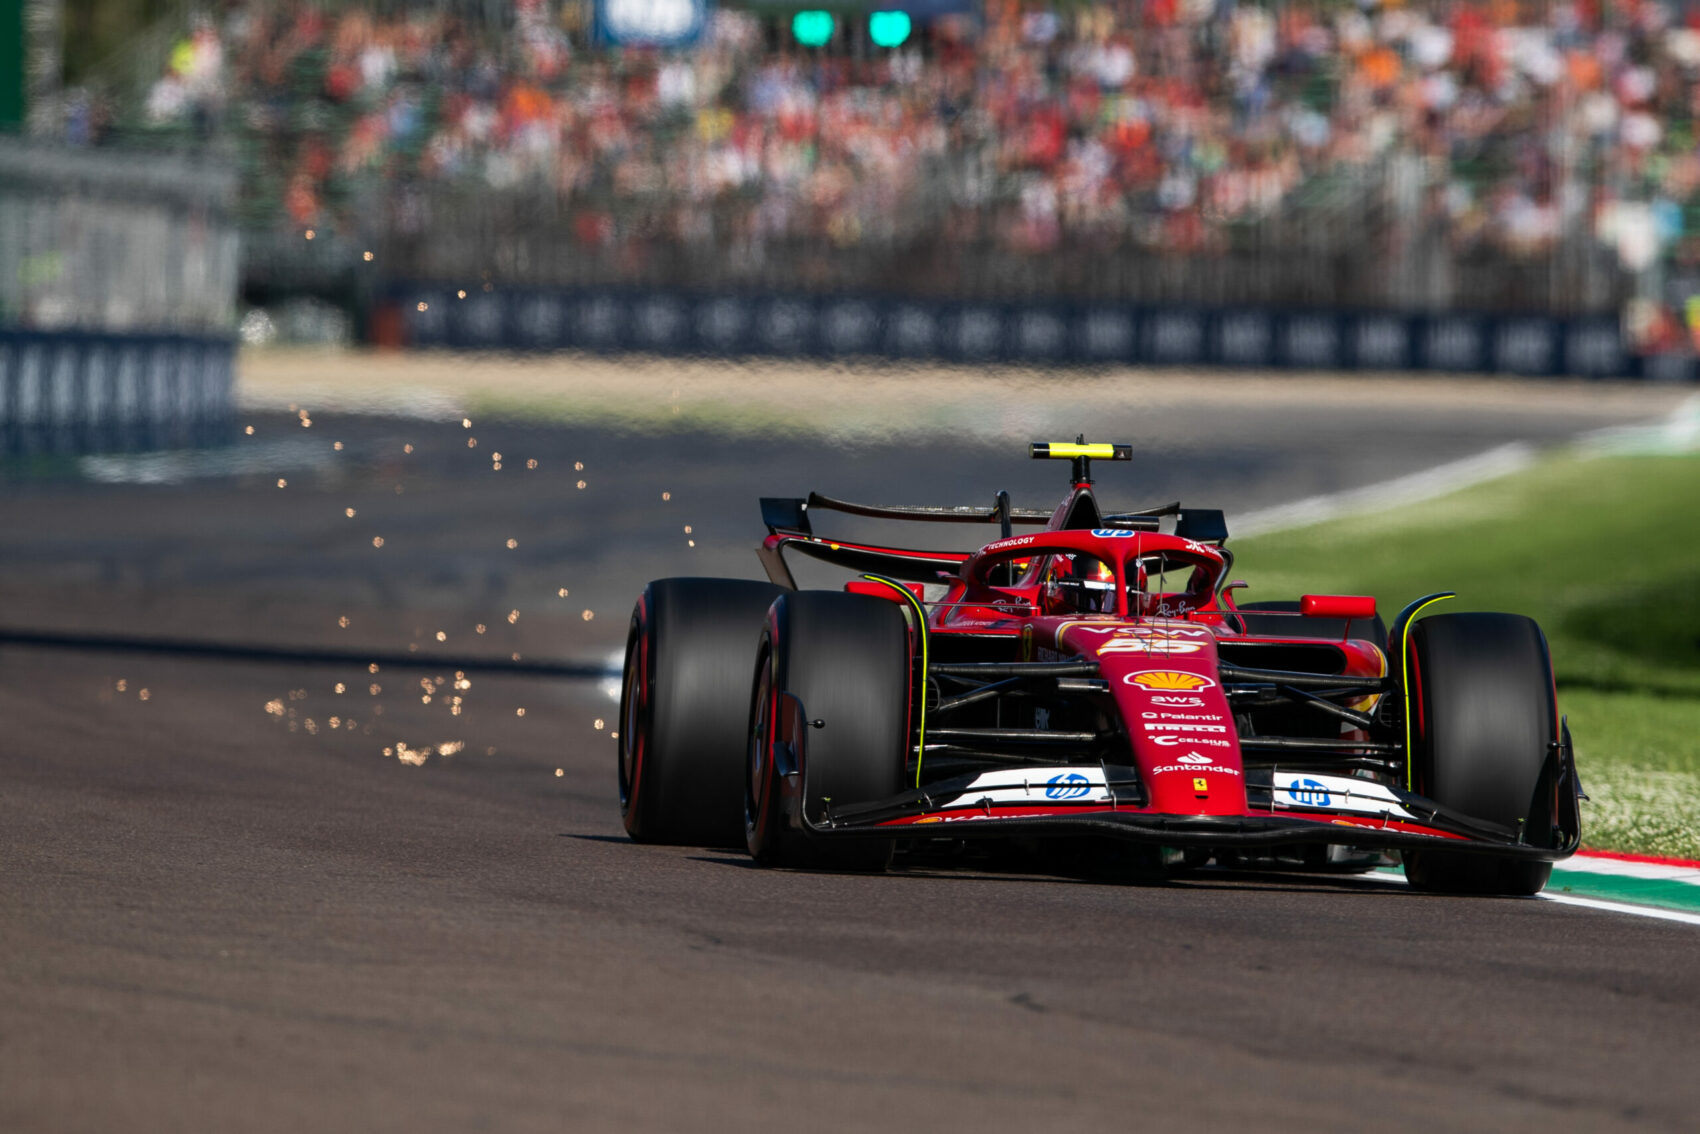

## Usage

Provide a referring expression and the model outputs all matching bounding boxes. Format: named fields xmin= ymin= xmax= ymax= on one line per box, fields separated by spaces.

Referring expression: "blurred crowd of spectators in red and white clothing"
xmin=89 ymin=0 xmax=1700 ymax=289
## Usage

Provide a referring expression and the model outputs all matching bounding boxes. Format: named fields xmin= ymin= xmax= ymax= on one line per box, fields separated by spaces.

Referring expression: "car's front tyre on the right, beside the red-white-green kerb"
xmin=1403 ymin=614 xmax=1559 ymax=894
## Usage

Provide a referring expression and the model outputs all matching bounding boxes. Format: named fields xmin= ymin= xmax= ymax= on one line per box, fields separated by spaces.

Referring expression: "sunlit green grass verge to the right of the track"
xmin=1231 ymin=456 xmax=1700 ymax=859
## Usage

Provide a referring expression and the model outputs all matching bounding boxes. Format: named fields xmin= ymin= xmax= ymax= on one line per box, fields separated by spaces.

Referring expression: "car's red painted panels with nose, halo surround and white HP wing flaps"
xmin=762 ymin=485 xmax=1464 ymax=840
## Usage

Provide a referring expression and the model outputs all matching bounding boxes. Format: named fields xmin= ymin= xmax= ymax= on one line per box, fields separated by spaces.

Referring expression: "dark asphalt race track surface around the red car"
xmin=0 ymin=379 xmax=1700 ymax=1131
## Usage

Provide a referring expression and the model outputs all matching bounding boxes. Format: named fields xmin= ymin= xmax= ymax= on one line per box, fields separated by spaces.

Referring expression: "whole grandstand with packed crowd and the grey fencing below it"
xmin=36 ymin=0 xmax=1700 ymax=362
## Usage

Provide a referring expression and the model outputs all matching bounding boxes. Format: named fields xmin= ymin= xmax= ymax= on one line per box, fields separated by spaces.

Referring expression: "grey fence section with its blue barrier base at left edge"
xmin=0 ymin=139 xmax=240 ymax=454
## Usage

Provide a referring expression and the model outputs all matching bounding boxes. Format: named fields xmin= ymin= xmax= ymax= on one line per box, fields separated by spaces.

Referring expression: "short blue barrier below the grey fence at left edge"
xmin=0 ymin=330 xmax=236 ymax=456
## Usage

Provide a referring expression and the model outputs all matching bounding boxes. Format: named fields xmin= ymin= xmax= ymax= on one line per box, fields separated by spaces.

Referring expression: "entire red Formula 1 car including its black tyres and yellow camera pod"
xmin=619 ymin=440 xmax=1581 ymax=894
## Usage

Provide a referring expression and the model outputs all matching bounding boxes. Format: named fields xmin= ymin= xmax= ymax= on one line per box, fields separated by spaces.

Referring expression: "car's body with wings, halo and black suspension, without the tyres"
xmin=758 ymin=469 xmax=1579 ymax=860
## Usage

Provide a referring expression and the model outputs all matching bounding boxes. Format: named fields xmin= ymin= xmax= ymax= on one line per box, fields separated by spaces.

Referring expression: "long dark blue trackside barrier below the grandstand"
xmin=389 ymin=284 xmax=1695 ymax=381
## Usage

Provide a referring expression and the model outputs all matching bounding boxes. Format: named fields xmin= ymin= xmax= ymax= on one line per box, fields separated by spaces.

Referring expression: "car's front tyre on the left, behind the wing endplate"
xmin=745 ymin=590 xmax=910 ymax=870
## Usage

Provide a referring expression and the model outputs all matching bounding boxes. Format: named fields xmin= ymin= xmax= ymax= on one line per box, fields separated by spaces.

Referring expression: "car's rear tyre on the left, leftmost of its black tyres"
xmin=619 ymin=578 xmax=784 ymax=847
